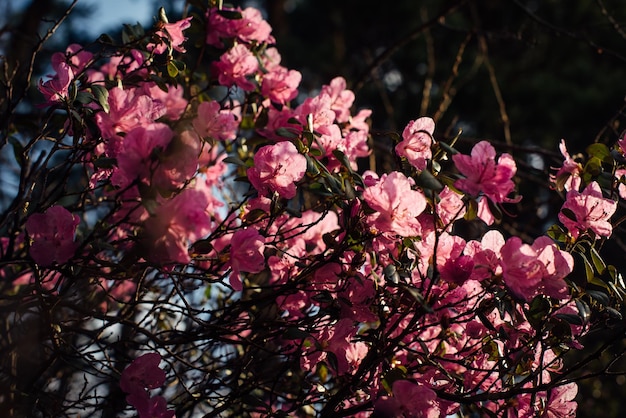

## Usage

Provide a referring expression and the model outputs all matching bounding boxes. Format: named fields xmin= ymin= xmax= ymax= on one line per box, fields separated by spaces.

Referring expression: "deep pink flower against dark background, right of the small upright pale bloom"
xmin=452 ymin=141 xmax=517 ymax=203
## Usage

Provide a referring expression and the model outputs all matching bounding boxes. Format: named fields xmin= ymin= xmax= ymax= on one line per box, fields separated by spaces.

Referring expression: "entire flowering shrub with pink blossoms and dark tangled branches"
xmin=0 ymin=1 xmax=625 ymax=417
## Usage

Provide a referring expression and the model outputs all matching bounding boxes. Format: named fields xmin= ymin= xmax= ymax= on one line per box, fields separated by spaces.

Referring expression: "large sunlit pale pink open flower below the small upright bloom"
xmin=363 ymin=171 xmax=426 ymax=237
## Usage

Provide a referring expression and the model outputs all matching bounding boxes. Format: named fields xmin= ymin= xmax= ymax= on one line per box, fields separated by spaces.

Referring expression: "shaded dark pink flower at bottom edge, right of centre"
xmin=374 ymin=380 xmax=445 ymax=418
